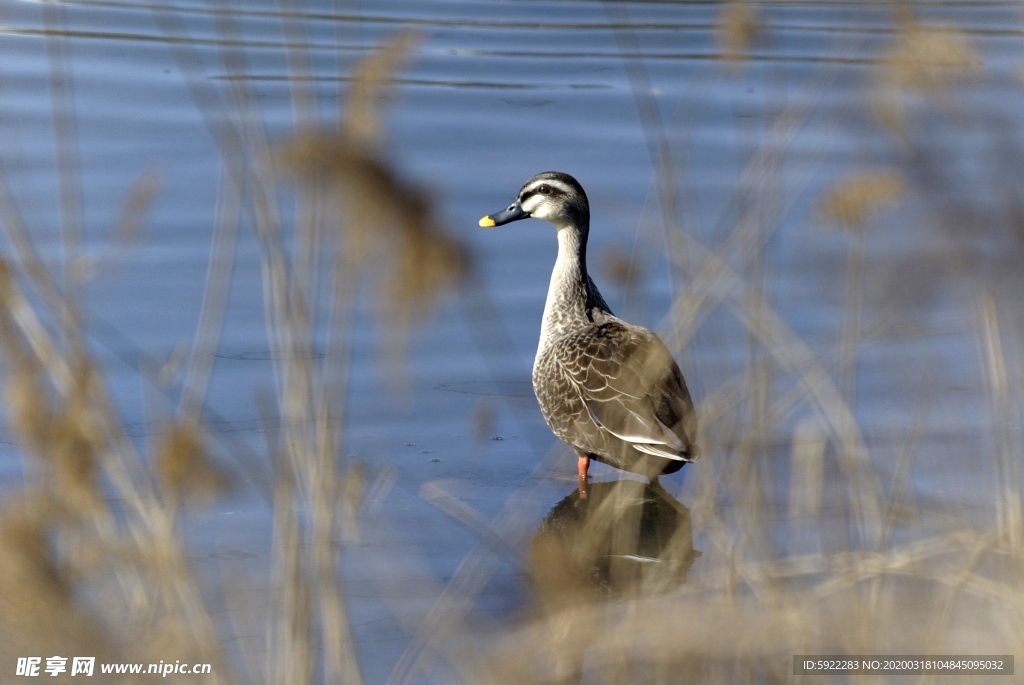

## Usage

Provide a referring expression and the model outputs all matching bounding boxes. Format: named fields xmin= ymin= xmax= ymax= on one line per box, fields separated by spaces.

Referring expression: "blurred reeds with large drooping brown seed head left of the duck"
xmin=239 ymin=29 xmax=466 ymax=683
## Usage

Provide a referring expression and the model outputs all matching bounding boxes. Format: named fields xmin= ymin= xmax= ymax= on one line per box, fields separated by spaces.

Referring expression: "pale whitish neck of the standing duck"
xmin=537 ymin=224 xmax=610 ymax=357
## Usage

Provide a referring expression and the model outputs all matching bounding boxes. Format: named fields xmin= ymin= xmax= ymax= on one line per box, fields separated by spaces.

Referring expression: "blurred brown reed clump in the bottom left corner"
xmin=0 ymin=211 xmax=229 ymax=682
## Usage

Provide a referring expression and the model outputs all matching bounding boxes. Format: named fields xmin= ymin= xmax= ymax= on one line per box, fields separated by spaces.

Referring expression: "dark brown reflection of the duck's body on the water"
xmin=530 ymin=480 xmax=700 ymax=597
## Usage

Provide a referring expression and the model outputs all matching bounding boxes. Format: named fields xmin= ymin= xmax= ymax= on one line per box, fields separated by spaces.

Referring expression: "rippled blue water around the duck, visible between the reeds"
xmin=0 ymin=0 xmax=1024 ymax=683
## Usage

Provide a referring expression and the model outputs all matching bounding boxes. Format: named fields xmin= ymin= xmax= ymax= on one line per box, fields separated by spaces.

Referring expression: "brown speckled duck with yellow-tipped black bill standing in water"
xmin=478 ymin=171 xmax=700 ymax=491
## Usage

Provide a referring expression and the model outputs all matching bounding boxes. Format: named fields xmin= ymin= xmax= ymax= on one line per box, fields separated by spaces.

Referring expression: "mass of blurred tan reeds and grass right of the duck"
xmin=489 ymin=2 xmax=1024 ymax=684
